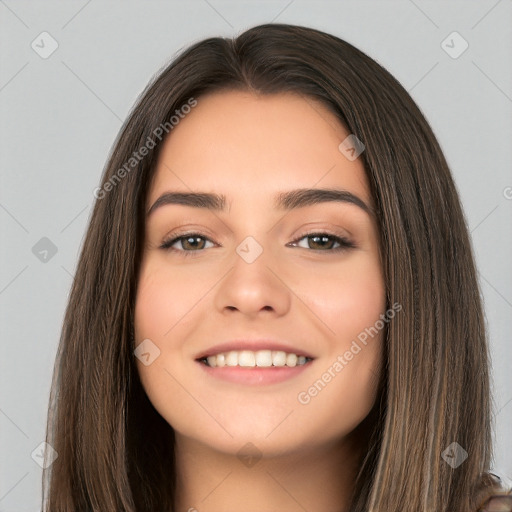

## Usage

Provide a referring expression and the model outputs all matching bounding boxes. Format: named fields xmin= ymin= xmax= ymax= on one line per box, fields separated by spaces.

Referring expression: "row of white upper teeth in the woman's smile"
xmin=202 ymin=350 xmax=310 ymax=368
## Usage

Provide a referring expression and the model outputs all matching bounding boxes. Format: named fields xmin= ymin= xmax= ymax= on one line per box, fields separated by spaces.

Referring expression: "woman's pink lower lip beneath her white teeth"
xmin=196 ymin=361 xmax=312 ymax=386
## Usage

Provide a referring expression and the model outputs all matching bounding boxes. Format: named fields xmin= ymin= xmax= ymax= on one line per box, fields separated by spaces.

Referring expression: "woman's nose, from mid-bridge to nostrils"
xmin=215 ymin=237 xmax=293 ymax=317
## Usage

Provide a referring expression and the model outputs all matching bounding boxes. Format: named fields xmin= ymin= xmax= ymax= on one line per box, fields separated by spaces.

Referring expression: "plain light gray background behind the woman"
xmin=0 ymin=0 xmax=512 ymax=512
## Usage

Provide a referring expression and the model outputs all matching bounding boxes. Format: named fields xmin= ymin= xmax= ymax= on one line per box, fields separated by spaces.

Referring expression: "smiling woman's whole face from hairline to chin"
xmin=135 ymin=91 xmax=385 ymax=455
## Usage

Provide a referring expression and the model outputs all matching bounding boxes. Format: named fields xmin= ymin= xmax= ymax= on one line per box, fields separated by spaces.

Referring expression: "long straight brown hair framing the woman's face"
xmin=43 ymin=24 xmax=504 ymax=512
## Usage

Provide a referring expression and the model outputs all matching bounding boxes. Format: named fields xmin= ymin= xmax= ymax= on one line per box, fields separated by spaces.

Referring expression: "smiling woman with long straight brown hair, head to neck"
xmin=44 ymin=24 xmax=512 ymax=512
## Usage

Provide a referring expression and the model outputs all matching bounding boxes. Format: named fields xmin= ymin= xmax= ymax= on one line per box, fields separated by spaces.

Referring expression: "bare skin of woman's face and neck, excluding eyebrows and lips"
xmin=135 ymin=91 xmax=385 ymax=512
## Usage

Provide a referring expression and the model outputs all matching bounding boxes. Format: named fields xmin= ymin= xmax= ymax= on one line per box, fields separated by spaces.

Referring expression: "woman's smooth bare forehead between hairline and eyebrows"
xmin=148 ymin=91 xmax=371 ymax=208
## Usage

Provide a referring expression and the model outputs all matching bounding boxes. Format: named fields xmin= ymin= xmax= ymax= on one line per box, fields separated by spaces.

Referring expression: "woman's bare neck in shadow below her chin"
xmin=175 ymin=434 xmax=360 ymax=512
